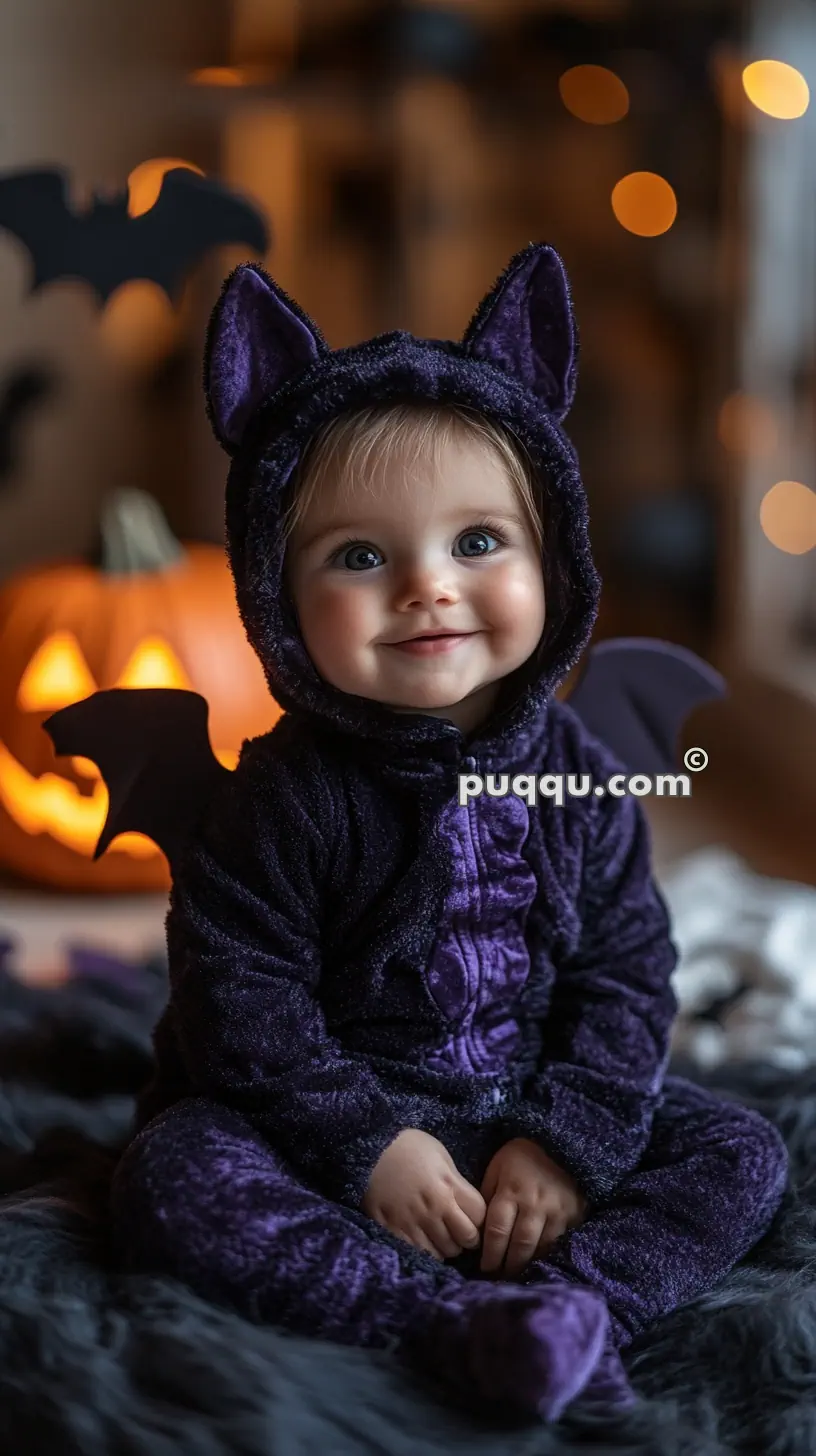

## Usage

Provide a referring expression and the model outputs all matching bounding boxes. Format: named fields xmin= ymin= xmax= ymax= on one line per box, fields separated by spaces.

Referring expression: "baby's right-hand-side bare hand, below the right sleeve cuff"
xmin=481 ymin=1137 xmax=587 ymax=1275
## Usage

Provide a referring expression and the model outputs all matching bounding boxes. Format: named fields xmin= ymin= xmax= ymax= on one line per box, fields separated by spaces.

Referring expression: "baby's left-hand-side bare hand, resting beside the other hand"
xmin=363 ymin=1127 xmax=485 ymax=1259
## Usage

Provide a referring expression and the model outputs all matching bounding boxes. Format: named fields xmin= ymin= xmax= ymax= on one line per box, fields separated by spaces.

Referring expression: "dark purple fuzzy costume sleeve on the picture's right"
xmin=513 ymin=763 xmax=678 ymax=1201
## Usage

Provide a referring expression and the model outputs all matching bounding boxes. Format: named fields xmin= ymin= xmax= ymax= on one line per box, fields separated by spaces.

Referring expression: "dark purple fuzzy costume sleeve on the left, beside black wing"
xmin=168 ymin=745 xmax=411 ymax=1207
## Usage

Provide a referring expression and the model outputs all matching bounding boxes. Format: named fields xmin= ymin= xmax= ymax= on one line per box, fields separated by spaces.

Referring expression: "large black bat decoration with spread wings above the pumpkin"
xmin=0 ymin=167 xmax=270 ymax=303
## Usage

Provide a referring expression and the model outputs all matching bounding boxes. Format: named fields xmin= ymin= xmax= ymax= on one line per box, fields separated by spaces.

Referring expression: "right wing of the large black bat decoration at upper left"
xmin=130 ymin=167 xmax=271 ymax=298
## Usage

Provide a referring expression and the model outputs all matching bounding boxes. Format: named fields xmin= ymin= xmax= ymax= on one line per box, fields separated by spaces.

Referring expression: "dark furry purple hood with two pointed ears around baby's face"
xmin=204 ymin=243 xmax=600 ymax=763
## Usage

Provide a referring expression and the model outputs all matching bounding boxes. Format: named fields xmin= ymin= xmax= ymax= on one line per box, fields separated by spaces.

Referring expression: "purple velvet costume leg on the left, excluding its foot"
xmin=112 ymin=1098 xmax=453 ymax=1347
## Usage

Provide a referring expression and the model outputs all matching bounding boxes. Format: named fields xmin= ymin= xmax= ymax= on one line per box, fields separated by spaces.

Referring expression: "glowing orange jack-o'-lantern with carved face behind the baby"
xmin=0 ymin=491 xmax=280 ymax=891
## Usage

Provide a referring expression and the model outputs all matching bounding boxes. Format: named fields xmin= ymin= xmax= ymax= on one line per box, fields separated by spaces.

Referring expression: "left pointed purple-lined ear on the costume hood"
xmin=204 ymin=264 xmax=329 ymax=454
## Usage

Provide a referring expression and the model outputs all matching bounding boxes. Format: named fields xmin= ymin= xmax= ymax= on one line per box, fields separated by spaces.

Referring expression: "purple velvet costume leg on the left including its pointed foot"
xmin=112 ymin=1098 xmax=609 ymax=1420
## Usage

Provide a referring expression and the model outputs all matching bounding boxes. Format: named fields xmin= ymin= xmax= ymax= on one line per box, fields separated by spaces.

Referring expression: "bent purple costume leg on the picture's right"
xmin=522 ymin=1077 xmax=788 ymax=1350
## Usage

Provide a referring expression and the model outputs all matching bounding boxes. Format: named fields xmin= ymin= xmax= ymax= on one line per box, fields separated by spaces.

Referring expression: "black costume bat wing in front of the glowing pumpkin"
xmin=42 ymin=687 xmax=229 ymax=869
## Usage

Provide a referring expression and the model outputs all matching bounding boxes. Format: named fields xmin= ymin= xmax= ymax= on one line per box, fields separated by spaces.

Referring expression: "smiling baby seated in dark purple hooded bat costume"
xmin=112 ymin=245 xmax=787 ymax=1421
